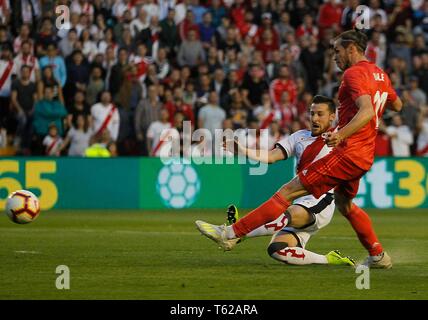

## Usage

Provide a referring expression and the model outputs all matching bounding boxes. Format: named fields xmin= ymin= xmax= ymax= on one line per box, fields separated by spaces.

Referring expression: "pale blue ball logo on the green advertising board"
xmin=156 ymin=162 xmax=201 ymax=209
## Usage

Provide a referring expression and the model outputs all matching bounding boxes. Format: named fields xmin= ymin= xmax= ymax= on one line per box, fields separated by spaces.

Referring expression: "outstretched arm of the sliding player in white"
xmin=223 ymin=140 xmax=285 ymax=163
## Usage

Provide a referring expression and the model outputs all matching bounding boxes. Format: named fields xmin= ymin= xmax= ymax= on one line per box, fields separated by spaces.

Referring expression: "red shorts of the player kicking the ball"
xmin=299 ymin=149 xmax=367 ymax=199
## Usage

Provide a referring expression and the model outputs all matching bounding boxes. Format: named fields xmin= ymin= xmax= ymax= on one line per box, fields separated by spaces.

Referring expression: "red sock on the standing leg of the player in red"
xmin=345 ymin=203 xmax=383 ymax=256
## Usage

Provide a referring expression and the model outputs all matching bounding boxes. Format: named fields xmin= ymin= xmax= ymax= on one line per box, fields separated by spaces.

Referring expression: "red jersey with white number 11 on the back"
xmin=338 ymin=61 xmax=397 ymax=170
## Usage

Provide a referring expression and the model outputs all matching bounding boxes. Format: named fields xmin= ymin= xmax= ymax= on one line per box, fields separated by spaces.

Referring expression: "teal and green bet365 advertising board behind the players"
xmin=0 ymin=158 xmax=428 ymax=210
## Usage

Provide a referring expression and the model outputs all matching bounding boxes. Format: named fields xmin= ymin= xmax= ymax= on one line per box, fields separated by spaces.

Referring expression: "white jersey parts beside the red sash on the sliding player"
xmin=276 ymin=130 xmax=333 ymax=174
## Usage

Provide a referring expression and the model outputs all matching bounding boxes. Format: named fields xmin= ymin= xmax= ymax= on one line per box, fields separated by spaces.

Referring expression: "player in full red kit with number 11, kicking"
xmin=199 ymin=30 xmax=402 ymax=268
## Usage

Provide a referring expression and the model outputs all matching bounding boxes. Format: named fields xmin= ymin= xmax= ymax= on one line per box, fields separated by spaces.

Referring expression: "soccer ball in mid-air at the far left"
xmin=6 ymin=190 xmax=40 ymax=224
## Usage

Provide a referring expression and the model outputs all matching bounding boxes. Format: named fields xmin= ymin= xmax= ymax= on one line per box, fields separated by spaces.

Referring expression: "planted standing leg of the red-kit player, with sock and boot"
xmin=334 ymin=189 xmax=392 ymax=269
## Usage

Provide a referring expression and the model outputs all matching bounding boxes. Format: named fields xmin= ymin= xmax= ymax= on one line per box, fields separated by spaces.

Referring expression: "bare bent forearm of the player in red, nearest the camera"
xmin=325 ymin=95 xmax=375 ymax=147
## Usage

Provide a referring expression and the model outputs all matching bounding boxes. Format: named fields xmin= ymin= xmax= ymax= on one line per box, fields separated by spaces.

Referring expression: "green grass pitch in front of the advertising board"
xmin=0 ymin=210 xmax=428 ymax=300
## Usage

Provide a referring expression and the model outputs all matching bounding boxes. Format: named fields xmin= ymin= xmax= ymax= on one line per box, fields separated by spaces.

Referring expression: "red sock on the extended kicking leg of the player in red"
xmin=232 ymin=192 xmax=291 ymax=238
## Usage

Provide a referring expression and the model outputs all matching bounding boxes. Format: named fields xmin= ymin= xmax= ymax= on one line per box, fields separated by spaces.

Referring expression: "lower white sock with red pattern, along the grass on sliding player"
xmin=272 ymin=247 xmax=328 ymax=265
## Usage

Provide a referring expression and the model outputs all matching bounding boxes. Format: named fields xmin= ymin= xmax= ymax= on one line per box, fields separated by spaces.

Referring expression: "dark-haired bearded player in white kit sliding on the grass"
xmin=196 ymin=96 xmax=354 ymax=266
